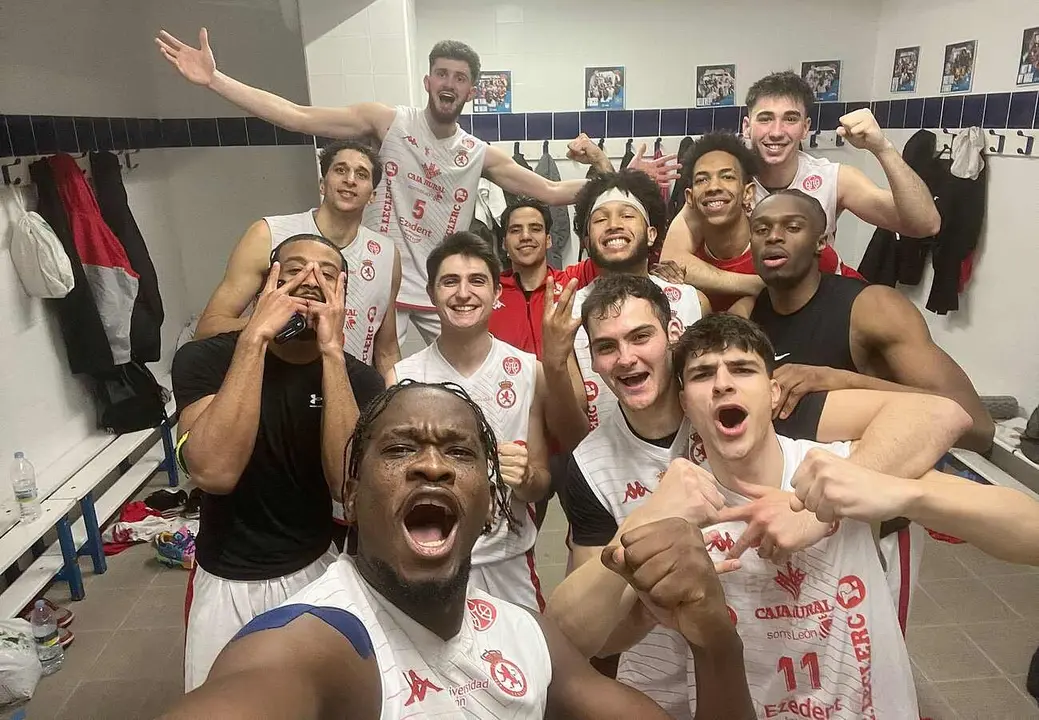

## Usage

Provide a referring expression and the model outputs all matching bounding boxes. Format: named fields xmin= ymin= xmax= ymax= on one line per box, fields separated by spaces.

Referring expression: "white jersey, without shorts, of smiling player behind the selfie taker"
xmin=394 ymin=338 xmax=537 ymax=573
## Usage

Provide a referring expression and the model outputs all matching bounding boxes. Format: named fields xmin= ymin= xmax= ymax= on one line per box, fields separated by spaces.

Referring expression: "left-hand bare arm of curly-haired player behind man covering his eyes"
xmin=194 ymin=220 xmax=271 ymax=340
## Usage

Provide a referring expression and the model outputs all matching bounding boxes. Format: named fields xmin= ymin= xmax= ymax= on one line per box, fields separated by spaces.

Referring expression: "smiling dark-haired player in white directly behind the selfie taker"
xmin=391 ymin=232 xmax=556 ymax=611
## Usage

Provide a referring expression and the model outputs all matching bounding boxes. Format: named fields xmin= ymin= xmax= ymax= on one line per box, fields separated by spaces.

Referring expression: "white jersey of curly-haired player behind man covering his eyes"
xmin=264 ymin=210 xmax=394 ymax=365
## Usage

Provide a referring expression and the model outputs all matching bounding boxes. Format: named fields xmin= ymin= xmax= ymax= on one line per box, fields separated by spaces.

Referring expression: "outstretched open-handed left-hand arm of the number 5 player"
xmin=155 ymin=28 xmax=394 ymax=142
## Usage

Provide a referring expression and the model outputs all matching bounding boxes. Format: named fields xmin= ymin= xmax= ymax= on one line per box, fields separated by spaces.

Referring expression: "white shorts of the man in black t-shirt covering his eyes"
xmin=184 ymin=546 xmax=339 ymax=693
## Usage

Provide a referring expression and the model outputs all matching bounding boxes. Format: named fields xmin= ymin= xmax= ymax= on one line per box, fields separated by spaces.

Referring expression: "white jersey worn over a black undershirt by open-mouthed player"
xmin=574 ymin=412 xmax=692 ymax=719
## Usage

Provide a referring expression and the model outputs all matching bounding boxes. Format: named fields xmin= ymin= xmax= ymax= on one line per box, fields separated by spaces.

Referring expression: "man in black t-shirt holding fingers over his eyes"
xmin=172 ymin=235 xmax=382 ymax=691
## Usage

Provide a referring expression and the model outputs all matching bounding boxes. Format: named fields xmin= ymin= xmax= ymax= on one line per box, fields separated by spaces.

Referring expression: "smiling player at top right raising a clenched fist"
xmin=662 ymin=71 xmax=941 ymax=295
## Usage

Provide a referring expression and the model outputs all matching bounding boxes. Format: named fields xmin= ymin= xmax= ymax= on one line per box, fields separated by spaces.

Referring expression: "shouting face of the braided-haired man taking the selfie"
xmin=344 ymin=386 xmax=490 ymax=596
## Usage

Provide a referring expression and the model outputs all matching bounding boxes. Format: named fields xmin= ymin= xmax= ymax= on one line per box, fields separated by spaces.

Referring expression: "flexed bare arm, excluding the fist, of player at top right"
xmin=837 ymin=155 xmax=941 ymax=238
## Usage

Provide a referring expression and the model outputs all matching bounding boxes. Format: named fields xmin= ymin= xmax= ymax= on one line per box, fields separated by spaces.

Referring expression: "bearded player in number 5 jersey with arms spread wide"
xmin=156 ymin=28 xmax=677 ymax=345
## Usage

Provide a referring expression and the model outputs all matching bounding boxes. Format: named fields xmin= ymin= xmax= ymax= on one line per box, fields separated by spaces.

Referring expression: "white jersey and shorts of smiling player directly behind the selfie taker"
xmin=394 ymin=337 xmax=544 ymax=610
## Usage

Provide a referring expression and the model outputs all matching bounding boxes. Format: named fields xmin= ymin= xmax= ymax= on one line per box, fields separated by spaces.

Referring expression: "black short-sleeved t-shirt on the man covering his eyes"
xmin=172 ymin=332 xmax=384 ymax=581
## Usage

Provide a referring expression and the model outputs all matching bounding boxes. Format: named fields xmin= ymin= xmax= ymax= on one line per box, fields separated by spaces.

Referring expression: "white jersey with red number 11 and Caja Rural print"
xmin=688 ymin=436 xmax=920 ymax=720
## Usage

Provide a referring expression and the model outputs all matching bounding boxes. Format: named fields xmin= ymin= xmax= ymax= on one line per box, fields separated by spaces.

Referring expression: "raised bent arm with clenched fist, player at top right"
xmin=837 ymin=108 xmax=941 ymax=238
